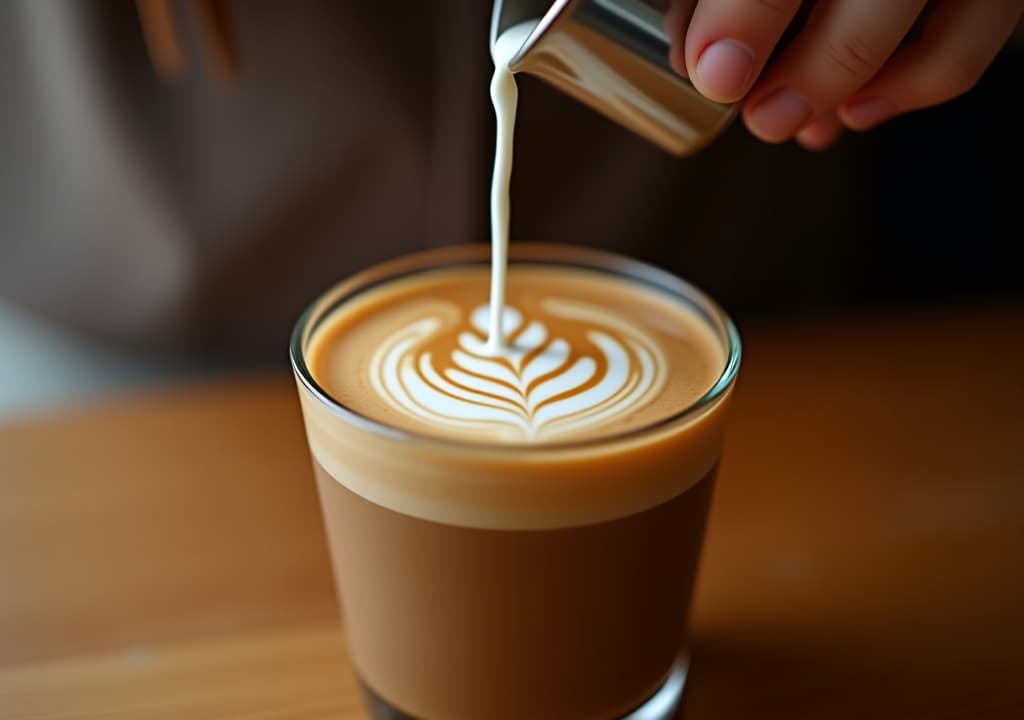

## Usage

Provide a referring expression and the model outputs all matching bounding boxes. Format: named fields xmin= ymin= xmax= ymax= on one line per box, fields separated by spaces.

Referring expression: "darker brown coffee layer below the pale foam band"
xmin=316 ymin=465 xmax=715 ymax=720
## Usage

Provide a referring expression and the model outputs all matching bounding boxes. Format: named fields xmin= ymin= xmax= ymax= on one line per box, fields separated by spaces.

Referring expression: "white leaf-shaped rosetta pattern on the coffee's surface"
xmin=369 ymin=299 xmax=666 ymax=441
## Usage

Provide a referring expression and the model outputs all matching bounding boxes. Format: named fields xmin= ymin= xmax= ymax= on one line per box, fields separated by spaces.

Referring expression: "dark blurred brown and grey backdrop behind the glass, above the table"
xmin=0 ymin=0 xmax=1024 ymax=419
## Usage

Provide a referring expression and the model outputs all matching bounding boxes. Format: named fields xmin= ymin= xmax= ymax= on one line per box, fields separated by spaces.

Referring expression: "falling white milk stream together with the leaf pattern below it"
xmin=362 ymin=20 xmax=666 ymax=441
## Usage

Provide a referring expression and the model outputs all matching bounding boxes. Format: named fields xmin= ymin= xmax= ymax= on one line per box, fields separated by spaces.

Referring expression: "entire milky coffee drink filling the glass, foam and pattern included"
xmin=300 ymin=262 xmax=727 ymax=720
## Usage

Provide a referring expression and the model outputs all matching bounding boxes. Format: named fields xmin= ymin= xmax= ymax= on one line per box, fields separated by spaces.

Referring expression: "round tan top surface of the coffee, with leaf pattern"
xmin=310 ymin=263 xmax=725 ymax=444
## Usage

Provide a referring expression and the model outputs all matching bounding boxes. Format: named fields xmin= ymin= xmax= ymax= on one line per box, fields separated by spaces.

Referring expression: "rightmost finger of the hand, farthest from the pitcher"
xmin=840 ymin=0 xmax=1024 ymax=130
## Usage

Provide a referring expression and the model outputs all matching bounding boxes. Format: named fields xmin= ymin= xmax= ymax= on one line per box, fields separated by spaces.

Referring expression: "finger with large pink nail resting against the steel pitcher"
xmin=673 ymin=0 xmax=800 ymax=102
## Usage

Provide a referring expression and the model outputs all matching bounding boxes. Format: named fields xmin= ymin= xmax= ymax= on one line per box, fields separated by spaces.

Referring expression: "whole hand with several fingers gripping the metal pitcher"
xmin=667 ymin=0 xmax=1024 ymax=150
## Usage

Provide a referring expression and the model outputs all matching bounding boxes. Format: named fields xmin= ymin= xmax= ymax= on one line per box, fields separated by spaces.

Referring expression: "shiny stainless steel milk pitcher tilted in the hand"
xmin=490 ymin=0 xmax=738 ymax=155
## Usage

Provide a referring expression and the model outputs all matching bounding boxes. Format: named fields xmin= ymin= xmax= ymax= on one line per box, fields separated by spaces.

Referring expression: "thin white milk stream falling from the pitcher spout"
xmin=486 ymin=20 xmax=538 ymax=354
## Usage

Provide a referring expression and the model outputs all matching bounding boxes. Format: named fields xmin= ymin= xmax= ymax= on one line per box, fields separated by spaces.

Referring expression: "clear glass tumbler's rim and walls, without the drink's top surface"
xmin=291 ymin=244 xmax=740 ymax=720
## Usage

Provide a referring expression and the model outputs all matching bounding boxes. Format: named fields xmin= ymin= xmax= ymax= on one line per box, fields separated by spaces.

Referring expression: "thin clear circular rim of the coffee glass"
xmin=289 ymin=243 xmax=742 ymax=454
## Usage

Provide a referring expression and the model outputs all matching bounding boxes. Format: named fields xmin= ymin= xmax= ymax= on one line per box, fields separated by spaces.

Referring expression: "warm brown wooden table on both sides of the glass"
xmin=0 ymin=308 xmax=1024 ymax=720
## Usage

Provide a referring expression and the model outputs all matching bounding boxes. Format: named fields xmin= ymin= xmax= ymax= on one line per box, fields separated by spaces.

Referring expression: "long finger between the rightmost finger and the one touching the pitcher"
xmin=743 ymin=0 xmax=927 ymax=142
